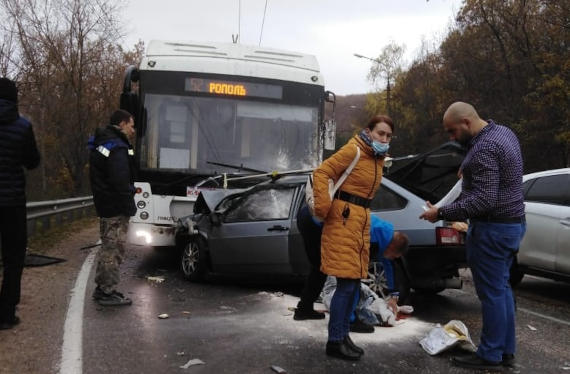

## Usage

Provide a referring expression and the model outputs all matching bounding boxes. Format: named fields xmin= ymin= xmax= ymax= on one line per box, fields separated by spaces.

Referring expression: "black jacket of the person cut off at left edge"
xmin=0 ymin=99 xmax=40 ymax=206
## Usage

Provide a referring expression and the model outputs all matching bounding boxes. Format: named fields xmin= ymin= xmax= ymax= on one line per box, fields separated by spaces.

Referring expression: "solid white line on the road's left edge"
xmin=59 ymin=249 xmax=97 ymax=374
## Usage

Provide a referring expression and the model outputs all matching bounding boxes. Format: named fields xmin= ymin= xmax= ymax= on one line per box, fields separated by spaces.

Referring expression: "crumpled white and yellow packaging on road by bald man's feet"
xmin=420 ymin=320 xmax=477 ymax=356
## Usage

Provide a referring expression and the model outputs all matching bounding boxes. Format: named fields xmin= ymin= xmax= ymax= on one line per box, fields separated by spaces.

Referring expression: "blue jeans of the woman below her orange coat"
xmin=329 ymin=278 xmax=360 ymax=342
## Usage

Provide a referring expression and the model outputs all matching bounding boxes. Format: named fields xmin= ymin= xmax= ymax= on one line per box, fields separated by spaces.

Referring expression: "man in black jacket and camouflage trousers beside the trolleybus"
xmin=89 ymin=110 xmax=136 ymax=306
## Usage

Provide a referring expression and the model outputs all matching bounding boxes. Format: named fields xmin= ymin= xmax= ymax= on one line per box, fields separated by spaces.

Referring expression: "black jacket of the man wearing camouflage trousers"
xmin=89 ymin=126 xmax=137 ymax=217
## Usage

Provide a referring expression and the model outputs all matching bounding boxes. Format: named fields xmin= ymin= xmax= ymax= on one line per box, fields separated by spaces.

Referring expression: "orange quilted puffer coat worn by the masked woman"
xmin=313 ymin=135 xmax=384 ymax=279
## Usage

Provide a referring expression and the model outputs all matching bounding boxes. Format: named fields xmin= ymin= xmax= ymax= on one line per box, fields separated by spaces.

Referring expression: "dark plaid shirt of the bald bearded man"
xmin=440 ymin=121 xmax=524 ymax=221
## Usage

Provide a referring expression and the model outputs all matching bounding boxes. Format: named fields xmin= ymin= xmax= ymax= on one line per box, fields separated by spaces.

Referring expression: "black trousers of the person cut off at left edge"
xmin=0 ymin=205 xmax=27 ymax=322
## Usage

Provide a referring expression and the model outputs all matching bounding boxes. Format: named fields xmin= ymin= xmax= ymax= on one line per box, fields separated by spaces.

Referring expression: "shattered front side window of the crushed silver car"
xmin=224 ymin=188 xmax=295 ymax=222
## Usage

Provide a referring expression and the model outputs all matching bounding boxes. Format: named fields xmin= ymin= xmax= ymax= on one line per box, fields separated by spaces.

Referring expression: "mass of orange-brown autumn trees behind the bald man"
xmin=369 ymin=0 xmax=570 ymax=172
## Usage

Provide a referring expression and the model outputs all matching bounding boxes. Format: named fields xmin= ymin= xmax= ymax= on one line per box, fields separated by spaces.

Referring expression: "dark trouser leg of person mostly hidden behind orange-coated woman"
xmin=297 ymin=205 xmax=327 ymax=310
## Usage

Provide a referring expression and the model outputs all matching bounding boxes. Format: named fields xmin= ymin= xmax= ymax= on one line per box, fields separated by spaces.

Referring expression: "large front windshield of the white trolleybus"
xmin=140 ymin=94 xmax=319 ymax=174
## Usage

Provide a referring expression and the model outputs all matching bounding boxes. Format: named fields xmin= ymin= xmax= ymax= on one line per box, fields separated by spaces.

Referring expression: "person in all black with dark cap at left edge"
xmin=0 ymin=78 xmax=40 ymax=330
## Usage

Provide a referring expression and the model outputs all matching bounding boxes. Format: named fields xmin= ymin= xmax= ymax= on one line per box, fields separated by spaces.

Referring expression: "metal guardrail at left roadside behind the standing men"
xmin=26 ymin=196 xmax=93 ymax=236
